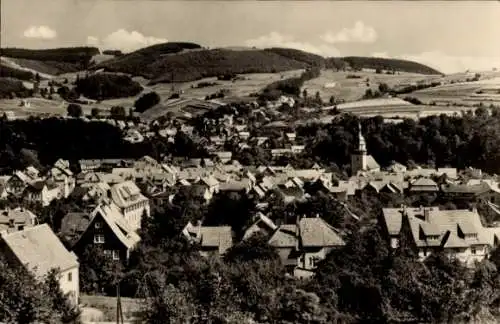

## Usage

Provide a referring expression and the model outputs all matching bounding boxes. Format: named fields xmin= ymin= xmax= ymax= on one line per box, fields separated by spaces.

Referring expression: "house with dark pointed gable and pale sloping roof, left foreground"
xmin=73 ymin=203 xmax=140 ymax=261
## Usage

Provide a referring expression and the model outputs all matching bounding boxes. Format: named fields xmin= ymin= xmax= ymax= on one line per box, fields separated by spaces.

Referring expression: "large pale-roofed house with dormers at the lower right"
xmin=380 ymin=206 xmax=491 ymax=266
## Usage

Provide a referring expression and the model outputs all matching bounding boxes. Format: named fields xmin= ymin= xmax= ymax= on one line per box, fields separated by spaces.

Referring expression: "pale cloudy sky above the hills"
xmin=1 ymin=0 xmax=500 ymax=73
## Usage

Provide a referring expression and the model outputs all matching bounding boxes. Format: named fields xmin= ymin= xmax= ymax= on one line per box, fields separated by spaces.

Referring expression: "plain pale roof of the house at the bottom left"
xmin=2 ymin=224 xmax=78 ymax=276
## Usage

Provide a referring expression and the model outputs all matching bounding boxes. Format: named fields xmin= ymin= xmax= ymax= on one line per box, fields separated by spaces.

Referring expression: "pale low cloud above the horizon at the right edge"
xmin=372 ymin=51 xmax=500 ymax=74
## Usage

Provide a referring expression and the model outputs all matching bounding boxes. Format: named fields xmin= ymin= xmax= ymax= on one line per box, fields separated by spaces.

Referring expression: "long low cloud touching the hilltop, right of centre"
xmin=245 ymin=32 xmax=340 ymax=56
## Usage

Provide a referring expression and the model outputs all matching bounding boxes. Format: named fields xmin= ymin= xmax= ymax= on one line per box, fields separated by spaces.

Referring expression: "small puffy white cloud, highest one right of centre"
xmin=321 ymin=21 xmax=377 ymax=44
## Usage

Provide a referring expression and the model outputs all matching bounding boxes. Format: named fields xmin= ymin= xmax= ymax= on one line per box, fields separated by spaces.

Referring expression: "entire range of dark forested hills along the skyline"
xmin=0 ymin=42 xmax=441 ymax=83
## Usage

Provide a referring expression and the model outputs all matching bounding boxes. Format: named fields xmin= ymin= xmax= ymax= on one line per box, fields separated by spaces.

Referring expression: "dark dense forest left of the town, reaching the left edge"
xmin=0 ymin=118 xmax=206 ymax=172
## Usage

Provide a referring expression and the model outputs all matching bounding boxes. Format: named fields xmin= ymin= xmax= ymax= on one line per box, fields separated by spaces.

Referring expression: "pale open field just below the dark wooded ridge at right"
xmin=303 ymin=70 xmax=441 ymax=101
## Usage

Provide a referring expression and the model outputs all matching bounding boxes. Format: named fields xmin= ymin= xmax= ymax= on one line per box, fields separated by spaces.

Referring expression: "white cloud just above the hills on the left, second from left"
xmin=87 ymin=29 xmax=167 ymax=52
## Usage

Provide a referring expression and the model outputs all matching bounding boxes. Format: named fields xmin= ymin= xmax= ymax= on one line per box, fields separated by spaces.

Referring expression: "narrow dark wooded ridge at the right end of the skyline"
xmin=342 ymin=56 xmax=442 ymax=75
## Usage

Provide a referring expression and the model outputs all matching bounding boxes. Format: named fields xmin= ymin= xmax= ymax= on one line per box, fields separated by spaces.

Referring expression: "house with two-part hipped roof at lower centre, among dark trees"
xmin=269 ymin=216 xmax=345 ymax=277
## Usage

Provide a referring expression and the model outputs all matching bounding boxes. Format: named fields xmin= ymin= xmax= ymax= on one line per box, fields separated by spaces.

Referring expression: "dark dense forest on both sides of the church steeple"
xmin=298 ymin=108 xmax=500 ymax=174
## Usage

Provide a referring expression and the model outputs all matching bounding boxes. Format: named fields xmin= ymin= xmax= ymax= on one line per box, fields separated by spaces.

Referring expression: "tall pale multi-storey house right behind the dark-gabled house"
xmin=110 ymin=181 xmax=150 ymax=230
